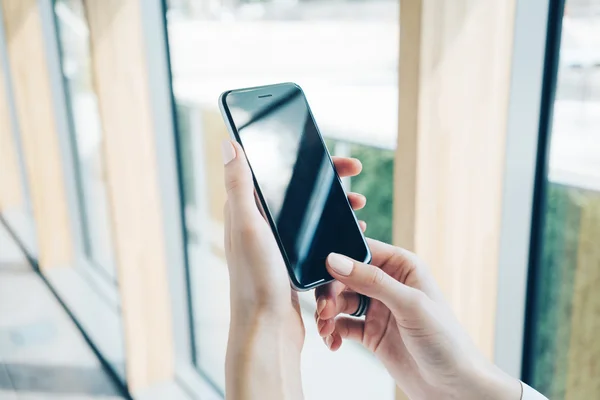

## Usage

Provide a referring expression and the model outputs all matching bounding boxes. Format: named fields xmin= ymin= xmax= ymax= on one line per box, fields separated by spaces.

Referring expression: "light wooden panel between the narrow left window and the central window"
xmin=85 ymin=0 xmax=174 ymax=394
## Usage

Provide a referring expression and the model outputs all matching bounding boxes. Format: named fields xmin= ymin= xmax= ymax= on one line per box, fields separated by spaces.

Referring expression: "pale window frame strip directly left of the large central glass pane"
xmin=140 ymin=0 xmax=223 ymax=400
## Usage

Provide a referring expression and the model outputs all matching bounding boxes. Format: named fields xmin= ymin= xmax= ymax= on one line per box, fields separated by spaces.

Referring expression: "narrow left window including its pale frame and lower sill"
xmin=52 ymin=0 xmax=126 ymax=383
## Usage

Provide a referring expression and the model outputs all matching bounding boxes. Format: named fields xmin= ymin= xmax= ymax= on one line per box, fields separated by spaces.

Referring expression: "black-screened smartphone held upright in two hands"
xmin=219 ymin=83 xmax=371 ymax=290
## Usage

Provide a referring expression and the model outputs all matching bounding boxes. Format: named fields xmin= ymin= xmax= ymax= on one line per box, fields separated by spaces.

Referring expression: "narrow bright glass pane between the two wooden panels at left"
xmin=54 ymin=0 xmax=116 ymax=282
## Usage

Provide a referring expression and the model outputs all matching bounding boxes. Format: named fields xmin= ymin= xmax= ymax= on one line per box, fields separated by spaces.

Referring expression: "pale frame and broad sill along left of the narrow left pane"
xmin=38 ymin=0 xmax=127 ymax=388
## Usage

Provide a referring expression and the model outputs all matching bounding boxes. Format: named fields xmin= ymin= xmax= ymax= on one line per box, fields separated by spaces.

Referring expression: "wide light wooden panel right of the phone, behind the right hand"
xmin=394 ymin=0 xmax=515 ymax=358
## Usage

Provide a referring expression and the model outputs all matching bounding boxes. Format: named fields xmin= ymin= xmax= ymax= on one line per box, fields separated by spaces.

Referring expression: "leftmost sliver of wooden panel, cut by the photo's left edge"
xmin=0 ymin=57 xmax=24 ymax=212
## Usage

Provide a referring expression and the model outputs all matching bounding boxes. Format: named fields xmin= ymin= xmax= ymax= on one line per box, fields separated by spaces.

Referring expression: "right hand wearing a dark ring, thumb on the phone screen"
xmin=315 ymin=240 xmax=521 ymax=400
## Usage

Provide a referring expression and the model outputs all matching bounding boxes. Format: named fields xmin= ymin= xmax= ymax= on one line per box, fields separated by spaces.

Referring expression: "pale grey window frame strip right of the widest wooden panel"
xmin=494 ymin=0 xmax=551 ymax=377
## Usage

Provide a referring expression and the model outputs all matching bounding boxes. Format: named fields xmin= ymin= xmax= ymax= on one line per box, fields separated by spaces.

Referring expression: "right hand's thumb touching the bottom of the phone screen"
xmin=327 ymin=253 xmax=425 ymax=315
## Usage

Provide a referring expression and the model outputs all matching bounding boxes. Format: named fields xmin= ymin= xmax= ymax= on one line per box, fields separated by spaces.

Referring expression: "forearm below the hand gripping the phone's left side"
xmin=225 ymin=313 xmax=303 ymax=400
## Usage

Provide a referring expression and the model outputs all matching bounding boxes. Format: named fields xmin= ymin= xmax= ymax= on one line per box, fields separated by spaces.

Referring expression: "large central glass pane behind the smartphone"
xmin=167 ymin=0 xmax=399 ymax=399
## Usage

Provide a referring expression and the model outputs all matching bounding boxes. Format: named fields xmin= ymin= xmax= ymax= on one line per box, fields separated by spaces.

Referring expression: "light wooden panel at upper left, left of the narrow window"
xmin=2 ymin=0 xmax=73 ymax=268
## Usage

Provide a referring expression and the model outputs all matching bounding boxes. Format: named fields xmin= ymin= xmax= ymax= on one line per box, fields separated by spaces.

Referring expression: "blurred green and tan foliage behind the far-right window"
xmin=531 ymin=183 xmax=600 ymax=399
